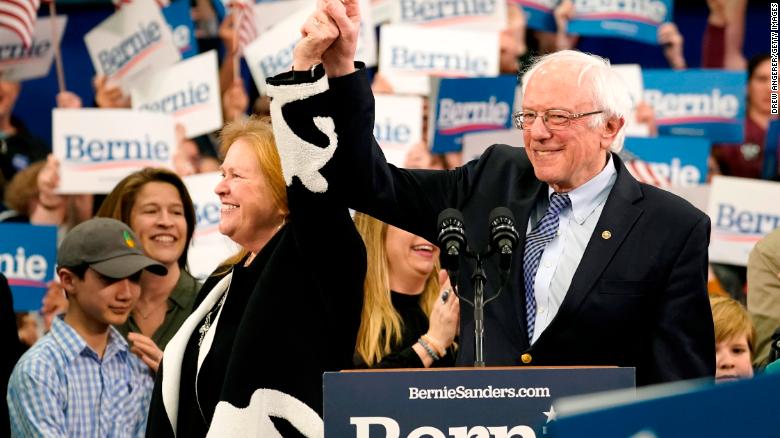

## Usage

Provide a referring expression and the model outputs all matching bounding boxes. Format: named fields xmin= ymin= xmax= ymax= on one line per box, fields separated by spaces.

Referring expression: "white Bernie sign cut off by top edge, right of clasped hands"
xmin=390 ymin=0 xmax=506 ymax=30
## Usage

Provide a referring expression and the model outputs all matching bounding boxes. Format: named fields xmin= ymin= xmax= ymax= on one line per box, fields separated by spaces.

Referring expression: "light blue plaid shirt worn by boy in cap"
xmin=8 ymin=318 xmax=154 ymax=438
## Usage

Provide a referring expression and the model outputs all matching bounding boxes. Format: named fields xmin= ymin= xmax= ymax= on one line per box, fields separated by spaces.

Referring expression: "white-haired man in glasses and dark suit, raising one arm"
xmin=269 ymin=0 xmax=715 ymax=385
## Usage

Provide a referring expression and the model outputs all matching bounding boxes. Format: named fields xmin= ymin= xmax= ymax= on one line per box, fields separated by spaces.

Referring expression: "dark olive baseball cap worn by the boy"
xmin=57 ymin=217 xmax=168 ymax=278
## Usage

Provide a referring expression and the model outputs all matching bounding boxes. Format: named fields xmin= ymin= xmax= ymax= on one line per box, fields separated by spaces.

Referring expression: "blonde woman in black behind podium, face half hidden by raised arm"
xmin=355 ymin=213 xmax=460 ymax=368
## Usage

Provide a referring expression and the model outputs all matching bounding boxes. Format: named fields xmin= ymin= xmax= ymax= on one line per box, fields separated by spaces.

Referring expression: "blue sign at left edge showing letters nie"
xmin=0 ymin=223 xmax=57 ymax=312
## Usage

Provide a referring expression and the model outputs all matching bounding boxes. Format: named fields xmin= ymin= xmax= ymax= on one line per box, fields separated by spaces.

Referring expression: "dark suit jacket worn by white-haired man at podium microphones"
xmin=272 ymin=66 xmax=715 ymax=385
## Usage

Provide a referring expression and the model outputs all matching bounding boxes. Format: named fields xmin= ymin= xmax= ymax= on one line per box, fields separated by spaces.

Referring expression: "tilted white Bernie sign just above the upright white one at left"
xmin=130 ymin=50 xmax=222 ymax=138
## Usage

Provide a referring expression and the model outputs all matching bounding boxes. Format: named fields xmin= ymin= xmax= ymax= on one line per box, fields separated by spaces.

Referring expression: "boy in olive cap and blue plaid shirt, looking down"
xmin=8 ymin=218 xmax=166 ymax=437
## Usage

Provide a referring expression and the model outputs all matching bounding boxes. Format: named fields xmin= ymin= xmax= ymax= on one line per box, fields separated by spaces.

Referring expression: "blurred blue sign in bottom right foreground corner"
xmin=549 ymin=374 xmax=780 ymax=438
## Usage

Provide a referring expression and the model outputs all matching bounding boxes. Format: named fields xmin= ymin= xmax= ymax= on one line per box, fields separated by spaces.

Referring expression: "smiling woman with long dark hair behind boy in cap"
xmin=97 ymin=168 xmax=201 ymax=372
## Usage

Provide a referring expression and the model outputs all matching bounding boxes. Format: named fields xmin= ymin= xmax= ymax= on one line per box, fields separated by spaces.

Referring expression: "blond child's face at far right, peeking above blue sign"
xmin=710 ymin=297 xmax=756 ymax=383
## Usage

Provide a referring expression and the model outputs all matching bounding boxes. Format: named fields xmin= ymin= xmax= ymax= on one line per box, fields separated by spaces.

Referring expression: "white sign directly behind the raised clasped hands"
xmin=244 ymin=0 xmax=376 ymax=94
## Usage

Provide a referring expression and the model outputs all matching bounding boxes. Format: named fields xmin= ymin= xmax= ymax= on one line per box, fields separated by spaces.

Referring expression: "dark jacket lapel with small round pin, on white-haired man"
xmin=542 ymin=154 xmax=643 ymax=328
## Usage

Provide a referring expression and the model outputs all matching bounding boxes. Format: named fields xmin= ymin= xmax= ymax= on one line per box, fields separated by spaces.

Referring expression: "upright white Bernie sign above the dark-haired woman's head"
xmin=52 ymin=108 xmax=176 ymax=194
